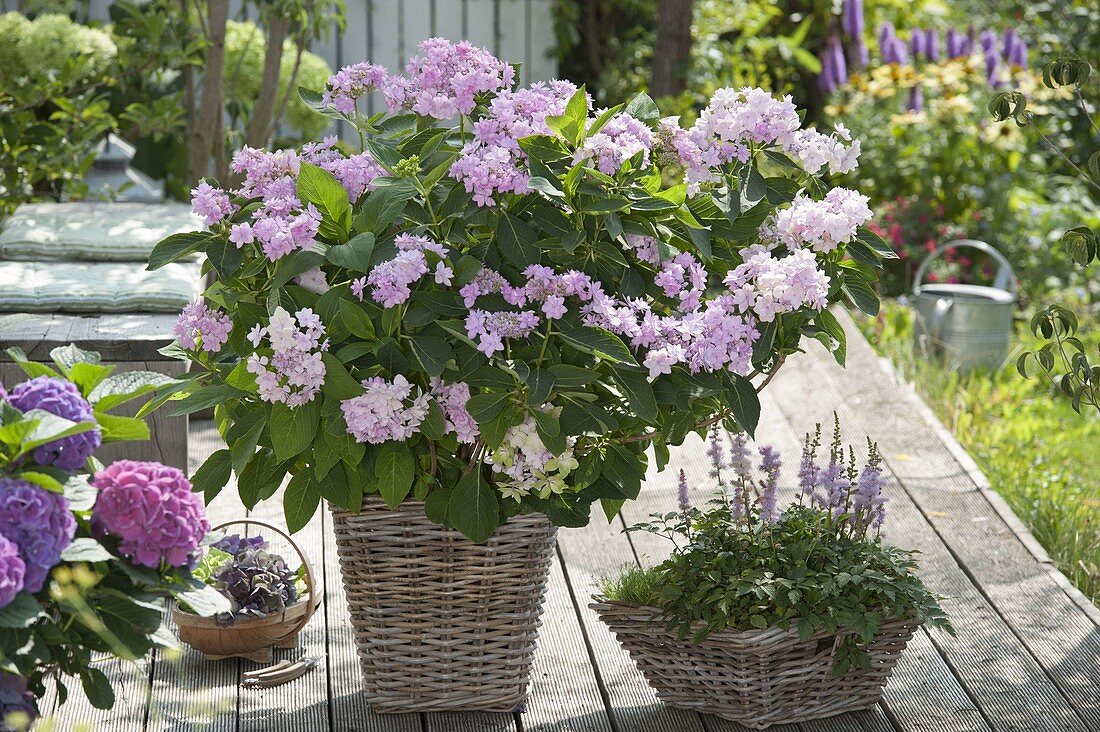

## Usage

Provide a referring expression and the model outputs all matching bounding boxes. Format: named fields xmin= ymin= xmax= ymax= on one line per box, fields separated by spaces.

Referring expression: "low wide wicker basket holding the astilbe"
xmin=591 ymin=598 xmax=917 ymax=730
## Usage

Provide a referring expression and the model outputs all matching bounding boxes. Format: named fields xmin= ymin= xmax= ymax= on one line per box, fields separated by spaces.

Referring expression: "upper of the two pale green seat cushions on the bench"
xmin=0 ymin=201 xmax=202 ymax=262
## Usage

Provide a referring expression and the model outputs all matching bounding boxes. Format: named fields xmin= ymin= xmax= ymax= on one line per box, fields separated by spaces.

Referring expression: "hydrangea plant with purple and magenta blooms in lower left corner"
xmin=0 ymin=346 xmax=229 ymax=730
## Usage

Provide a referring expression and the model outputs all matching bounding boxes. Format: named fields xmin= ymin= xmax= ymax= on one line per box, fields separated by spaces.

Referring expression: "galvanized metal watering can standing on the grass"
xmin=913 ymin=239 xmax=1016 ymax=371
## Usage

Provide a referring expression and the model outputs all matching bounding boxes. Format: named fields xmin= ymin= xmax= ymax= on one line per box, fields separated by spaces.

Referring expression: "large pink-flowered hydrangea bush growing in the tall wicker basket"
xmin=151 ymin=39 xmax=890 ymax=542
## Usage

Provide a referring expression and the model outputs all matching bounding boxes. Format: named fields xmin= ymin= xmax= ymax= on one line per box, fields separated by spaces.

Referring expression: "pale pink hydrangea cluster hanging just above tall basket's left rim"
xmin=340 ymin=374 xmax=430 ymax=445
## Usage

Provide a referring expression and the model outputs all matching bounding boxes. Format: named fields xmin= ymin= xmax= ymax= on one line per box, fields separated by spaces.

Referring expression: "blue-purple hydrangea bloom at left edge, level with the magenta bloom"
xmin=0 ymin=478 xmax=76 ymax=592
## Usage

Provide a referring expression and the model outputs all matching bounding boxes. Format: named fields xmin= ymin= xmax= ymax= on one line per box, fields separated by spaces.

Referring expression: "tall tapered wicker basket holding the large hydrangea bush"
xmin=330 ymin=496 xmax=557 ymax=713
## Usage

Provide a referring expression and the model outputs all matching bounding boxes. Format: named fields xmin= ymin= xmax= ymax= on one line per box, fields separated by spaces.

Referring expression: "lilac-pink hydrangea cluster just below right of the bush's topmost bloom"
xmin=450 ymin=81 xmax=576 ymax=206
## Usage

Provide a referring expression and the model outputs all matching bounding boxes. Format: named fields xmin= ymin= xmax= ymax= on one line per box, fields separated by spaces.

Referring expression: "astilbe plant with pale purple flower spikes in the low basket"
xmin=602 ymin=425 xmax=953 ymax=674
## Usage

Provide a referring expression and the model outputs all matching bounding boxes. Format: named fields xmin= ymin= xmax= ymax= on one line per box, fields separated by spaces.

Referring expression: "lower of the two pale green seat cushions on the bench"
xmin=0 ymin=262 xmax=201 ymax=313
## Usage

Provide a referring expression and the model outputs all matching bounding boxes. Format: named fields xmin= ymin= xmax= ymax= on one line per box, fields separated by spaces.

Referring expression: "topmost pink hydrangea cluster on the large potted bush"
xmin=386 ymin=39 xmax=516 ymax=120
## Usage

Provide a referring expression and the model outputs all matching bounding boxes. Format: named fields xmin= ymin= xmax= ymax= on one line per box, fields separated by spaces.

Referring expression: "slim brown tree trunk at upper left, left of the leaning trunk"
xmin=187 ymin=0 xmax=229 ymax=185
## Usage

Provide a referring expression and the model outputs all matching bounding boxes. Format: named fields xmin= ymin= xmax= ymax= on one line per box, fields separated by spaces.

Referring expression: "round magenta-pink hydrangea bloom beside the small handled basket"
xmin=91 ymin=460 xmax=210 ymax=568
